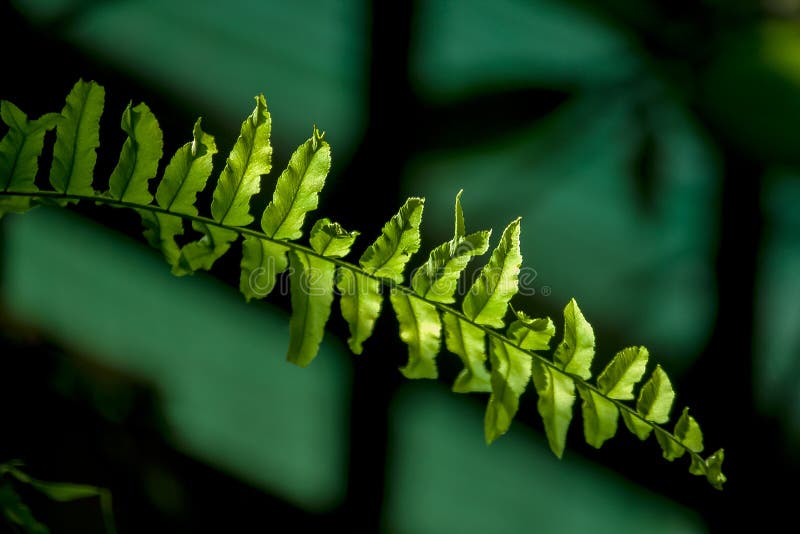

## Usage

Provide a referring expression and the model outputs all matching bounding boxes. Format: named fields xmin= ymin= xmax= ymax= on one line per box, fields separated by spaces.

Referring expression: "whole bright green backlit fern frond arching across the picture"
xmin=0 ymin=80 xmax=725 ymax=489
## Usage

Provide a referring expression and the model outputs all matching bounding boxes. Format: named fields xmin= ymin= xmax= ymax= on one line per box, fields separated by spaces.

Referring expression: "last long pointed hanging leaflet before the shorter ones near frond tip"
xmin=533 ymin=360 xmax=575 ymax=458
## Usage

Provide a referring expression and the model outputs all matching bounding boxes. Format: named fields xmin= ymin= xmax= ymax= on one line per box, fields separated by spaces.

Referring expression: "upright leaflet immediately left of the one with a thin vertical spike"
xmin=358 ymin=197 xmax=425 ymax=284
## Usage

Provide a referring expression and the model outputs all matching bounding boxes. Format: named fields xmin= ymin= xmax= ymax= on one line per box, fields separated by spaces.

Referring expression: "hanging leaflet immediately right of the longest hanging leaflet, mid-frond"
xmin=336 ymin=269 xmax=383 ymax=354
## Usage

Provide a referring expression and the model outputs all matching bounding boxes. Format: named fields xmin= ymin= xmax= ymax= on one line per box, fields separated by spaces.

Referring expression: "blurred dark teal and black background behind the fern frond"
xmin=0 ymin=0 xmax=800 ymax=533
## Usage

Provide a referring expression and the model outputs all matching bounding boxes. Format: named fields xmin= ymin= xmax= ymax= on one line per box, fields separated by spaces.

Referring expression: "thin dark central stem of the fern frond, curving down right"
xmin=0 ymin=187 xmax=702 ymax=461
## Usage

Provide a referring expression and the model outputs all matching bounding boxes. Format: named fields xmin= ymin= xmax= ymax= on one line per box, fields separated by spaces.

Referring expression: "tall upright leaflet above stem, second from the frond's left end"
xmin=50 ymin=80 xmax=105 ymax=204
